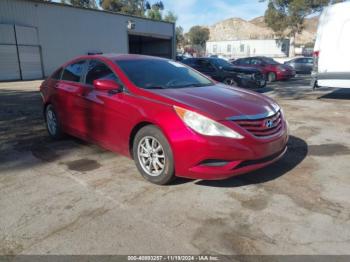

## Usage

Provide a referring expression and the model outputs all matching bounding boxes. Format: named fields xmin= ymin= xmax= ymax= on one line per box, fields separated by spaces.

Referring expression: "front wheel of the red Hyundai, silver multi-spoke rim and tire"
xmin=132 ymin=125 xmax=175 ymax=185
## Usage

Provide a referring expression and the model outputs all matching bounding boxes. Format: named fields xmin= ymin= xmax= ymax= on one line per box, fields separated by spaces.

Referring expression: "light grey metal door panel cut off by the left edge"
xmin=0 ymin=45 xmax=21 ymax=81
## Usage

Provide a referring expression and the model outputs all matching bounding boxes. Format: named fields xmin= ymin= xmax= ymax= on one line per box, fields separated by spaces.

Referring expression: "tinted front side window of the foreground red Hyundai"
xmin=85 ymin=60 xmax=118 ymax=85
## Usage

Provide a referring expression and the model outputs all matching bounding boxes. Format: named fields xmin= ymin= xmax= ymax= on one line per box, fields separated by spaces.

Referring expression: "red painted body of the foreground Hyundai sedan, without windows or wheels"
xmin=40 ymin=55 xmax=288 ymax=179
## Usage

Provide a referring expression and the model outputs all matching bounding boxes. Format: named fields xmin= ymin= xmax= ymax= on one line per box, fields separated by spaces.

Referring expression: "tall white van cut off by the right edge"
xmin=311 ymin=2 xmax=350 ymax=88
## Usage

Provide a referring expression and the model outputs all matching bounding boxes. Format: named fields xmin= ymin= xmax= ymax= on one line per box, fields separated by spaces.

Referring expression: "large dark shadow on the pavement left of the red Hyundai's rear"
xmin=0 ymin=90 xmax=102 ymax=169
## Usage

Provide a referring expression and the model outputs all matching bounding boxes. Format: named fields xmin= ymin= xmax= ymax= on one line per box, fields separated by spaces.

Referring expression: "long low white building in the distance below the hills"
xmin=206 ymin=39 xmax=289 ymax=58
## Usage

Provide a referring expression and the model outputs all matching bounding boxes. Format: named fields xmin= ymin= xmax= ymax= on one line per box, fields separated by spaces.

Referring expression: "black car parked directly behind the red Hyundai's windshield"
xmin=182 ymin=57 xmax=266 ymax=88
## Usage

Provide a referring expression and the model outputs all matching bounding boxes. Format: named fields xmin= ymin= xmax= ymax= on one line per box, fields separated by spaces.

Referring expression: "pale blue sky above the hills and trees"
xmin=161 ymin=0 xmax=268 ymax=32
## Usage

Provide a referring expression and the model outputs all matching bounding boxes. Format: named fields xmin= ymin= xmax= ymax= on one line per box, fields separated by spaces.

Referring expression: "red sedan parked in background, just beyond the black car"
xmin=233 ymin=56 xmax=295 ymax=82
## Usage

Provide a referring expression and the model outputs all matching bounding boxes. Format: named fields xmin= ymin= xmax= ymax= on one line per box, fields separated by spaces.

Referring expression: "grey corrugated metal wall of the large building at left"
xmin=0 ymin=0 xmax=175 ymax=76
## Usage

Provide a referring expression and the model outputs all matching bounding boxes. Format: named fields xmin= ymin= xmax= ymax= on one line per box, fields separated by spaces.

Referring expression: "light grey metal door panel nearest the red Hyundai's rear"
xmin=18 ymin=46 xmax=43 ymax=80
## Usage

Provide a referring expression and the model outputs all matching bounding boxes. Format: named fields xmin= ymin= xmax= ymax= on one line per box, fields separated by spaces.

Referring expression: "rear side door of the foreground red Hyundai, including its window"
xmin=53 ymin=60 xmax=86 ymax=136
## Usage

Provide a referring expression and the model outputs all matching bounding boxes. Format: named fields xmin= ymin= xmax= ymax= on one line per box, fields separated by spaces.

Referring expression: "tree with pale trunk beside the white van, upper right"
xmin=262 ymin=0 xmax=340 ymax=56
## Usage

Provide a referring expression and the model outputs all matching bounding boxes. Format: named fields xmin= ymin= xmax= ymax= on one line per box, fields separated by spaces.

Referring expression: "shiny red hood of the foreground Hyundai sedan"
xmin=151 ymin=84 xmax=279 ymax=120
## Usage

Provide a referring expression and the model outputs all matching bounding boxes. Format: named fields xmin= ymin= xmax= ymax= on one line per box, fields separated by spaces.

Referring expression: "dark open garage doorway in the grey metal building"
xmin=129 ymin=35 xmax=172 ymax=58
